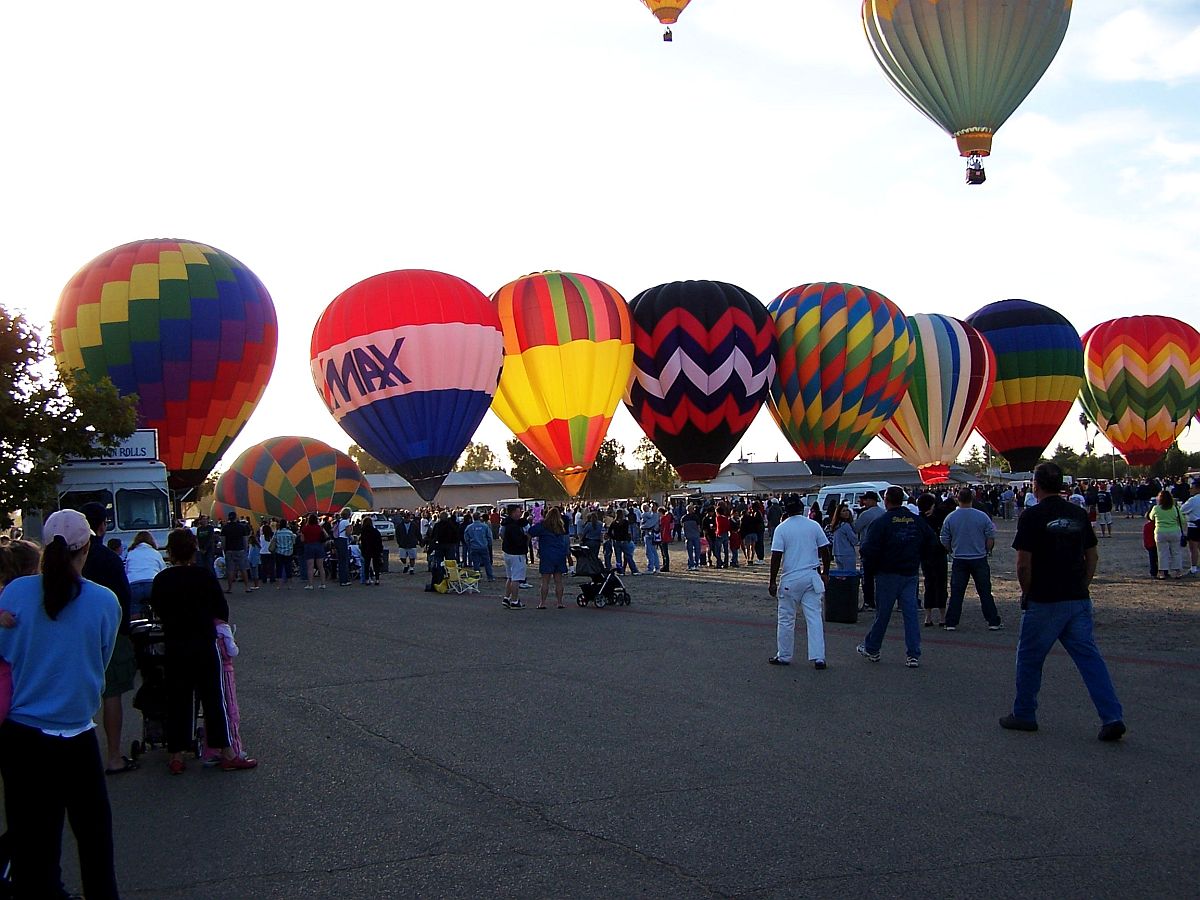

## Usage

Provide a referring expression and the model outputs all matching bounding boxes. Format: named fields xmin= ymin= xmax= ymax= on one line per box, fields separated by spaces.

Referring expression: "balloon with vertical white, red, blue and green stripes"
xmin=880 ymin=314 xmax=996 ymax=485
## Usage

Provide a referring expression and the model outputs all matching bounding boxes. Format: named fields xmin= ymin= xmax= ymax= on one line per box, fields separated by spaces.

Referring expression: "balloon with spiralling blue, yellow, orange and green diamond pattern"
xmin=768 ymin=282 xmax=917 ymax=475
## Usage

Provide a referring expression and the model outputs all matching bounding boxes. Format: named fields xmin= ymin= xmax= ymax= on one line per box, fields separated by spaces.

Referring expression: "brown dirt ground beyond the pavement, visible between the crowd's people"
xmin=568 ymin=516 xmax=1200 ymax=662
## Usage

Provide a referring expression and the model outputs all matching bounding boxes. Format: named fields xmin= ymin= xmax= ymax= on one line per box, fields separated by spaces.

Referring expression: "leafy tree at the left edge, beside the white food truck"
xmin=0 ymin=306 xmax=138 ymax=518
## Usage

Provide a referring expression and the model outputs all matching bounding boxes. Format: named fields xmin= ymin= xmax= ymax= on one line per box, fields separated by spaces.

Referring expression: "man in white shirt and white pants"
xmin=767 ymin=493 xmax=829 ymax=668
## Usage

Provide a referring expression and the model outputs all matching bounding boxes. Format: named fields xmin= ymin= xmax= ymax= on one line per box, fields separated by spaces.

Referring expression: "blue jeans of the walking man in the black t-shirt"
xmin=1013 ymin=600 xmax=1124 ymax=725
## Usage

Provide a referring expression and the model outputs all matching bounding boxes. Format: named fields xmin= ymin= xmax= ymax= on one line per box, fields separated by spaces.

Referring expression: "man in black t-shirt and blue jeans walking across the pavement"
xmin=1000 ymin=462 xmax=1126 ymax=740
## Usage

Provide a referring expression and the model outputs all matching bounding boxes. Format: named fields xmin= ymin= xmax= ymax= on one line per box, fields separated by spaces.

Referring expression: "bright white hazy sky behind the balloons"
xmin=0 ymin=0 xmax=1200 ymax=480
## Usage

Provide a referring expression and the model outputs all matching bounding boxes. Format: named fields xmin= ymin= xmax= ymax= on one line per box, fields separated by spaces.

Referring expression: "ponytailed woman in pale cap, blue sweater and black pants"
xmin=0 ymin=510 xmax=121 ymax=900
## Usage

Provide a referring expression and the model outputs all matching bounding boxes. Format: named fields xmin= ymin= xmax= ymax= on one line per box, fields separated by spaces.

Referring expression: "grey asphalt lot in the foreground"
xmin=51 ymin=540 xmax=1200 ymax=898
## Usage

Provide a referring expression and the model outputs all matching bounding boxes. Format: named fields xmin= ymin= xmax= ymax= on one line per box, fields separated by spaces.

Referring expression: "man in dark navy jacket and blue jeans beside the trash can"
xmin=854 ymin=485 xmax=937 ymax=668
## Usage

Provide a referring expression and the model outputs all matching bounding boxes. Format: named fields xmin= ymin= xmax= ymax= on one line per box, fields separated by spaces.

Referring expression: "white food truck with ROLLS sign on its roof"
xmin=58 ymin=428 xmax=172 ymax=550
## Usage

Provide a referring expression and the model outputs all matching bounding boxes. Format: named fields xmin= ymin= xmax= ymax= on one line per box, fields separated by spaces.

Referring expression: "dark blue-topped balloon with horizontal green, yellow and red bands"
xmin=967 ymin=300 xmax=1084 ymax=472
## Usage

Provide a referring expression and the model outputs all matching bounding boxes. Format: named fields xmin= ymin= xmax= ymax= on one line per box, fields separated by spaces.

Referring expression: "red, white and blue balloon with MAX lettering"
xmin=311 ymin=269 xmax=504 ymax=500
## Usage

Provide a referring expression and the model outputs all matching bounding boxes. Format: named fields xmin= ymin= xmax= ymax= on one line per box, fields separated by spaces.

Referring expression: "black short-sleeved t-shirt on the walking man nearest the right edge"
xmin=1013 ymin=494 xmax=1097 ymax=604
